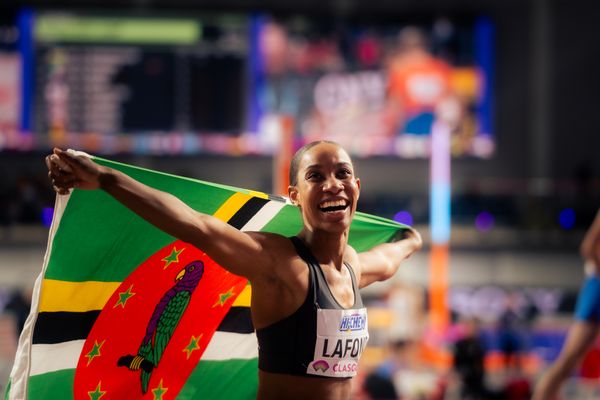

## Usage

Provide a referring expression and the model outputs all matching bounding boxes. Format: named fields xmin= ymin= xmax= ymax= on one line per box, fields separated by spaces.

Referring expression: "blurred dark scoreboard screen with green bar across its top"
xmin=33 ymin=13 xmax=248 ymax=139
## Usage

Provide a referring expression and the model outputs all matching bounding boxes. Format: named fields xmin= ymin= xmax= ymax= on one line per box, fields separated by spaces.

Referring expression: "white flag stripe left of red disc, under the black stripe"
xmin=31 ymin=340 xmax=85 ymax=376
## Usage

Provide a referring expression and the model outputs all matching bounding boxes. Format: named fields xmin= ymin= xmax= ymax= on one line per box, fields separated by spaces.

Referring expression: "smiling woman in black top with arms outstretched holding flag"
xmin=46 ymin=141 xmax=421 ymax=399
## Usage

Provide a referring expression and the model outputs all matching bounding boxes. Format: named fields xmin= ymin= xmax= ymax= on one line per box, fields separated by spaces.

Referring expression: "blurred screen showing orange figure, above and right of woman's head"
xmin=259 ymin=14 xmax=494 ymax=158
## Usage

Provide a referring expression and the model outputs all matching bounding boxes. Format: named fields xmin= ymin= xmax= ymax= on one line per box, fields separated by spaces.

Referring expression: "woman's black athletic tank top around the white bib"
xmin=256 ymin=237 xmax=363 ymax=375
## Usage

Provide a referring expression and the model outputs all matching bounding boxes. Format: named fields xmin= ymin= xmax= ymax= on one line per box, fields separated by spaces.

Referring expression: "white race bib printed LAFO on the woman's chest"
xmin=306 ymin=308 xmax=369 ymax=378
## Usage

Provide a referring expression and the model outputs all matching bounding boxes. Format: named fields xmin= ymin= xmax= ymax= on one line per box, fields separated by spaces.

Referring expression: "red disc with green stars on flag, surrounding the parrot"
xmin=73 ymin=241 xmax=247 ymax=399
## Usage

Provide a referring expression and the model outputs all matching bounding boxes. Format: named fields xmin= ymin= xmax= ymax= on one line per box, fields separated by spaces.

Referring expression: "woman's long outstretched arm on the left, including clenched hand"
xmin=46 ymin=149 xmax=272 ymax=279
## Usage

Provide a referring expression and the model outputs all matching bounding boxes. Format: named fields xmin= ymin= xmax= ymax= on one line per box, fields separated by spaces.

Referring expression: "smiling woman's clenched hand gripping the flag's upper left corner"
xmin=46 ymin=148 xmax=103 ymax=194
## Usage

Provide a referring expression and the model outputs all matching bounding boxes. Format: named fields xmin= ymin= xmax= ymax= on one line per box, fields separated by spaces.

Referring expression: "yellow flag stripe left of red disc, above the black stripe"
xmin=39 ymin=279 xmax=121 ymax=312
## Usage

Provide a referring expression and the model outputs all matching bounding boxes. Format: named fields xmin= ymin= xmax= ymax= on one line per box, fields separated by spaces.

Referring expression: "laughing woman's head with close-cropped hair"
xmin=288 ymin=143 xmax=360 ymax=232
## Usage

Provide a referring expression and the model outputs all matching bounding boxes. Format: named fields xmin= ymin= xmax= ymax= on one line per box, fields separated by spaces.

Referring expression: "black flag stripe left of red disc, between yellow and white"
xmin=32 ymin=310 xmax=100 ymax=344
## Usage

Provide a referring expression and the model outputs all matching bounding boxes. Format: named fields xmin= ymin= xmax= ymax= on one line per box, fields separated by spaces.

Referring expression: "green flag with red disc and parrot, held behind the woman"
xmin=5 ymin=157 xmax=404 ymax=400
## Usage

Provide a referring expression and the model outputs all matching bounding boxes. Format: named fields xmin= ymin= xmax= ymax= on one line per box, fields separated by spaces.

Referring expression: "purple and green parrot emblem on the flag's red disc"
xmin=117 ymin=261 xmax=204 ymax=393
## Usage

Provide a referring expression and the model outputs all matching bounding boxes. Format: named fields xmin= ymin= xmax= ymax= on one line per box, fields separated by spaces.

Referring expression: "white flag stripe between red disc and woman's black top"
xmin=201 ymin=331 xmax=258 ymax=361
